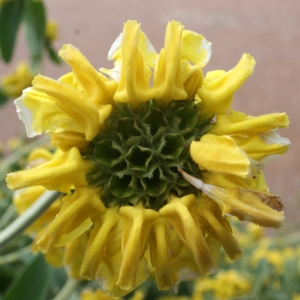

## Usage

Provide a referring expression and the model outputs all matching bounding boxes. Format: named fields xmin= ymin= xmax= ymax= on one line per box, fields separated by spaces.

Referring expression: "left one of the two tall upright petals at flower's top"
xmin=114 ymin=21 xmax=153 ymax=104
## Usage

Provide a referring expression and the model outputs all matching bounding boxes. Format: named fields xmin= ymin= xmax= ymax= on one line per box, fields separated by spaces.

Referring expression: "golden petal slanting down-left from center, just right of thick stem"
xmin=37 ymin=188 xmax=105 ymax=253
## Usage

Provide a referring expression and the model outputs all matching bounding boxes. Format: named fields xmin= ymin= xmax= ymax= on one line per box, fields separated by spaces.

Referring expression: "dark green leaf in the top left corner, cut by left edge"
xmin=0 ymin=1 xmax=24 ymax=63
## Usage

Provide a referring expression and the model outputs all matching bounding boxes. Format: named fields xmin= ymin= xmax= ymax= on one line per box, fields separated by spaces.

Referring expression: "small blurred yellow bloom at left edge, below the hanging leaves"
xmin=0 ymin=62 xmax=35 ymax=98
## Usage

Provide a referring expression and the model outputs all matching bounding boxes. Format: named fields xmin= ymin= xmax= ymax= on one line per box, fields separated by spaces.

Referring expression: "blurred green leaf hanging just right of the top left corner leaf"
xmin=24 ymin=0 xmax=46 ymax=71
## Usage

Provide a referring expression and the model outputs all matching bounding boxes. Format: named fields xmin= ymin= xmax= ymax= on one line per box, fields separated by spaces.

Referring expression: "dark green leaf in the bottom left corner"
xmin=2 ymin=255 xmax=50 ymax=300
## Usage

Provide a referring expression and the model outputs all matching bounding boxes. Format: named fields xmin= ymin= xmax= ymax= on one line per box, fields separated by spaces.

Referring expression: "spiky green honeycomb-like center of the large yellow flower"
xmin=83 ymin=100 xmax=211 ymax=210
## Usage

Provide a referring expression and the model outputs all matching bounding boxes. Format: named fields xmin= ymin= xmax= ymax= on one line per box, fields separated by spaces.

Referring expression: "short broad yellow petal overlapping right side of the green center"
xmin=190 ymin=134 xmax=250 ymax=177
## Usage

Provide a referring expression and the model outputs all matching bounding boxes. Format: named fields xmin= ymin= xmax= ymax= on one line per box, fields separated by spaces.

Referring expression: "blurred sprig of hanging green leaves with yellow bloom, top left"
xmin=0 ymin=0 xmax=61 ymax=106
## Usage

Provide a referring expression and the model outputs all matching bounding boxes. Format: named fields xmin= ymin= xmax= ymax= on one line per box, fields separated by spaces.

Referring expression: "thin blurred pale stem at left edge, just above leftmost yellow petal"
xmin=0 ymin=138 xmax=48 ymax=181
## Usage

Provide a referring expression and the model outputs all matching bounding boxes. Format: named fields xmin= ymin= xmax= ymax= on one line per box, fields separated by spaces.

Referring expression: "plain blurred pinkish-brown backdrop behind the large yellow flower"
xmin=0 ymin=0 xmax=300 ymax=223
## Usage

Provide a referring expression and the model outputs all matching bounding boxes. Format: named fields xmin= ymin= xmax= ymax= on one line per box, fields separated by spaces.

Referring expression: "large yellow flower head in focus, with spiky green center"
xmin=7 ymin=21 xmax=289 ymax=296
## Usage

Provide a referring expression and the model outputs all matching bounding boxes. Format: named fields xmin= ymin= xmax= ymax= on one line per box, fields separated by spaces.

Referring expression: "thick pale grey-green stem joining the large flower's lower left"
xmin=0 ymin=191 xmax=60 ymax=248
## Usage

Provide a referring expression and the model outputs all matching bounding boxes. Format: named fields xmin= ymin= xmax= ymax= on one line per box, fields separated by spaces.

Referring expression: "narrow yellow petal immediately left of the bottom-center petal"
xmin=80 ymin=206 xmax=121 ymax=280
